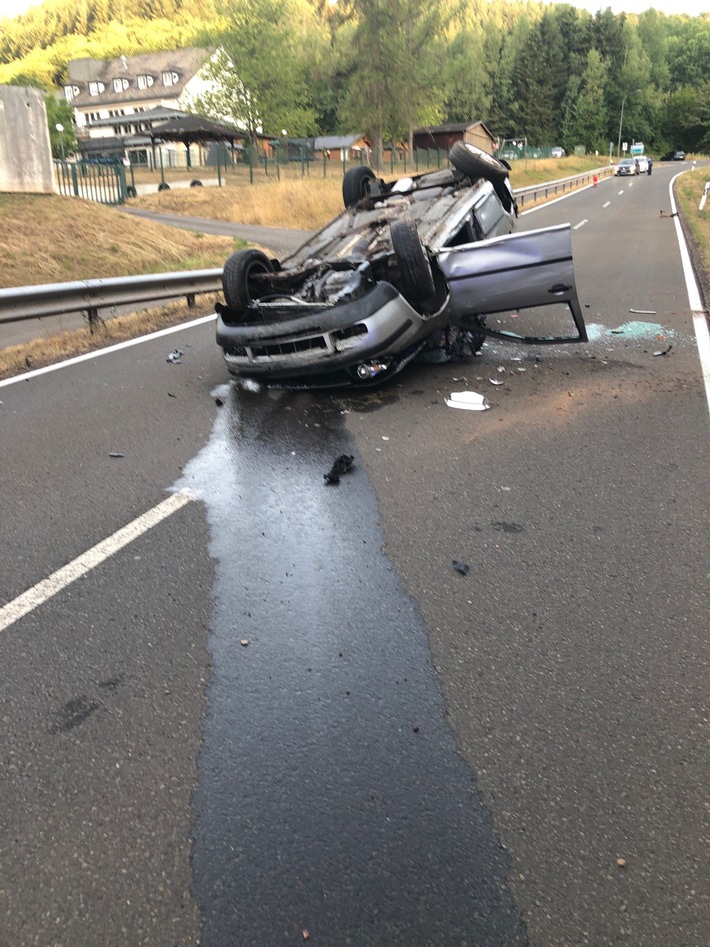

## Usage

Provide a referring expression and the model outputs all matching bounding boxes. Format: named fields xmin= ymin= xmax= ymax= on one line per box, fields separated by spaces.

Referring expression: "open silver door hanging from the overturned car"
xmin=435 ymin=224 xmax=587 ymax=343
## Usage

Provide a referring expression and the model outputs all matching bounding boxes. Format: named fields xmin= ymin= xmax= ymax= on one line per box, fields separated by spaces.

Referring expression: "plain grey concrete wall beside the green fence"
xmin=0 ymin=85 xmax=55 ymax=194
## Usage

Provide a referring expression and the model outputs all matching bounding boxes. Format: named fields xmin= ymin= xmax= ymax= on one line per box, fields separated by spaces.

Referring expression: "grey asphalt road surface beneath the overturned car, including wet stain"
xmin=0 ymin=159 xmax=710 ymax=947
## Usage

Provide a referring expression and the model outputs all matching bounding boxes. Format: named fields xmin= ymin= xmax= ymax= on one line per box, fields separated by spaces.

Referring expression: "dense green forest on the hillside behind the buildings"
xmin=0 ymin=0 xmax=710 ymax=154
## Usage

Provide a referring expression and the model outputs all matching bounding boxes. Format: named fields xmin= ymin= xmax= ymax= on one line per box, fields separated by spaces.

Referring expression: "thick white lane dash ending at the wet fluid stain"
xmin=0 ymin=490 xmax=193 ymax=631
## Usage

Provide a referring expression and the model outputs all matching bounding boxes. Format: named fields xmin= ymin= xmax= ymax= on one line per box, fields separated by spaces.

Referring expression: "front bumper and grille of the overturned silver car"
xmin=217 ymin=282 xmax=447 ymax=384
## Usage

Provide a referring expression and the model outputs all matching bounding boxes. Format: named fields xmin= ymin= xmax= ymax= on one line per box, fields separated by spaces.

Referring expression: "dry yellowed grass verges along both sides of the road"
xmin=0 ymin=157 xmax=710 ymax=378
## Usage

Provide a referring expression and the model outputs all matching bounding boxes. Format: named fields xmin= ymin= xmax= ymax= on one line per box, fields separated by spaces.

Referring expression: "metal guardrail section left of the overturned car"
xmin=0 ymin=269 xmax=222 ymax=325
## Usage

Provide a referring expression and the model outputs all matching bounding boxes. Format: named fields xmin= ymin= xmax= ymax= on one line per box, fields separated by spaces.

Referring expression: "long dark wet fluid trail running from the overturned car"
xmin=178 ymin=387 xmax=527 ymax=947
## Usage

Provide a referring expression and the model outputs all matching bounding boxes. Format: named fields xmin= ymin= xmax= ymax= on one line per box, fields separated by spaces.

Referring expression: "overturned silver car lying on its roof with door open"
xmin=216 ymin=142 xmax=587 ymax=387
